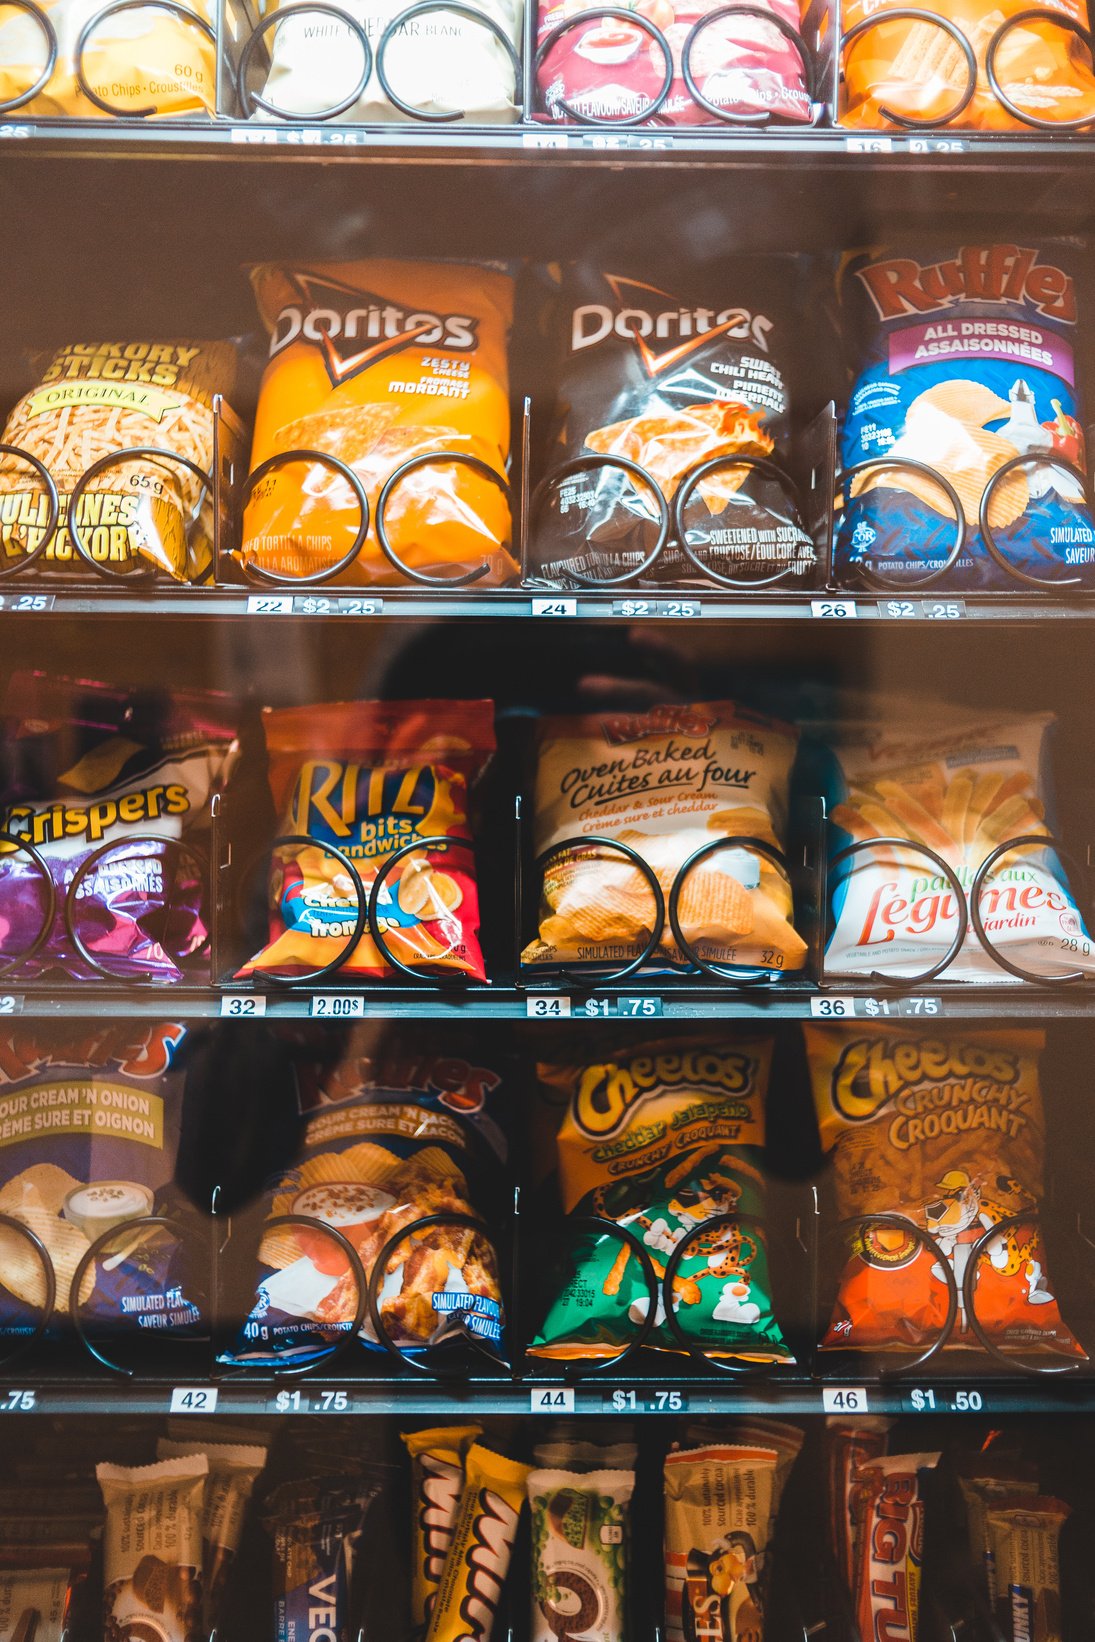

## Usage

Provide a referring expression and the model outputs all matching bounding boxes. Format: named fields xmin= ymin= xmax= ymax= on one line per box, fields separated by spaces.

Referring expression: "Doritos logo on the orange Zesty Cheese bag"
xmin=269 ymin=274 xmax=478 ymax=388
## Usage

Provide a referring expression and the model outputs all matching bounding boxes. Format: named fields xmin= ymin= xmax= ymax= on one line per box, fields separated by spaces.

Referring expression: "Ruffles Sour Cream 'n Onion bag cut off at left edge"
xmin=0 ymin=1021 xmax=199 ymax=1340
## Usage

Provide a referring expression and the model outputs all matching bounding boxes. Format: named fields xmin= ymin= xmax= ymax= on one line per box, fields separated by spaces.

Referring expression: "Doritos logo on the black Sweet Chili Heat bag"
xmin=570 ymin=274 xmax=772 ymax=367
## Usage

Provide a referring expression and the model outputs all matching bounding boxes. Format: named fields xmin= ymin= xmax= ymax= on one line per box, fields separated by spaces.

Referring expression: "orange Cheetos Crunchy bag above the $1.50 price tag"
xmin=803 ymin=1025 xmax=1085 ymax=1356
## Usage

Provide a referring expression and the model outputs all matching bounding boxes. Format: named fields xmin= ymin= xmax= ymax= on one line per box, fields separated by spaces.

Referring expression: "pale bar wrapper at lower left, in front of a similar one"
xmin=95 ymin=1455 xmax=208 ymax=1642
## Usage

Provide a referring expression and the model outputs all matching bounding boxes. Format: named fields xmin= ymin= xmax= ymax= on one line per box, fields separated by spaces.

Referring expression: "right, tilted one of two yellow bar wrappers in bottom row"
xmin=425 ymin=1443 xmax=532 ymax=1642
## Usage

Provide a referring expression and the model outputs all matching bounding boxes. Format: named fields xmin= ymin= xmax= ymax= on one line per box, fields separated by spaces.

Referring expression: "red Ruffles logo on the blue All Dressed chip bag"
xmin=857 ymin=245 xmax=1075 ymax=325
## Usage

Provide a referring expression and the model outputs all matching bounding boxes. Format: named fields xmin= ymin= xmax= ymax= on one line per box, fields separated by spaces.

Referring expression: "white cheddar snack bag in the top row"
xmin=256 ymin=0 xmax=522 ymax=125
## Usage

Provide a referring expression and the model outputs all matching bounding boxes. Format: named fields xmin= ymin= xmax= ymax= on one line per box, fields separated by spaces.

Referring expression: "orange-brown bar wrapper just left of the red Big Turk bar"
xmin=665 ymin=1429 xmax=801 ymax=1642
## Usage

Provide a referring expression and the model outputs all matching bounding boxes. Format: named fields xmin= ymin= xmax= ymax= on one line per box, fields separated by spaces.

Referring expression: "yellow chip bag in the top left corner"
xmin=0 ymin=0 xmax=217 ymax=117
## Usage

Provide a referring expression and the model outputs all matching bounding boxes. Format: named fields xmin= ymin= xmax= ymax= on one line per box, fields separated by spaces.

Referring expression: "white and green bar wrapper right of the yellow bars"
xmin=529 ymin=1470 xmax=635 ymax=1642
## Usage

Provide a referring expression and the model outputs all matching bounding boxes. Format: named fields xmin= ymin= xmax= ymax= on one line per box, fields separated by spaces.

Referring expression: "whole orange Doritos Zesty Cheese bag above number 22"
xmin=241 ymin=252 xmax=517 ymax=586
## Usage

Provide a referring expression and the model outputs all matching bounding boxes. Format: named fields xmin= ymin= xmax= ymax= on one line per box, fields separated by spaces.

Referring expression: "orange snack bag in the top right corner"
xmin=839 ymin=0 xmax=1095 ymax=131
